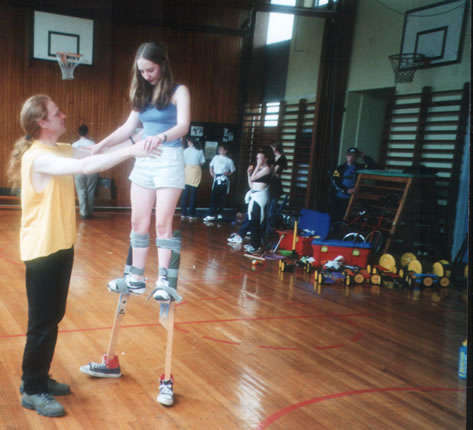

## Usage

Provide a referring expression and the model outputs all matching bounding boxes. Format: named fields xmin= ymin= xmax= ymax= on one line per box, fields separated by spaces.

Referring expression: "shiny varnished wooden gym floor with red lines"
xmin=0 ymin=209 xmax=466 ymax=430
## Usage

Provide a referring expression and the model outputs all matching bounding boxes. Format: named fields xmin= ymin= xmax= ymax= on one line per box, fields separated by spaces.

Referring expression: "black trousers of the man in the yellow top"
xmin=22 ymin=248 xmax=74 ymax=394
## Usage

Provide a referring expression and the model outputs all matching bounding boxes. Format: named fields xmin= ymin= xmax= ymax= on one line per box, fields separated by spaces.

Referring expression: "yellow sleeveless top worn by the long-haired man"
xmin=20 ymin=141 xmax=76 ymax=261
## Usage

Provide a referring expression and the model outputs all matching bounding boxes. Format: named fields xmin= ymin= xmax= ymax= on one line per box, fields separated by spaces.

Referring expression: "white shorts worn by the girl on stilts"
xmin=128 ymin=147 xmax=184 ymax=190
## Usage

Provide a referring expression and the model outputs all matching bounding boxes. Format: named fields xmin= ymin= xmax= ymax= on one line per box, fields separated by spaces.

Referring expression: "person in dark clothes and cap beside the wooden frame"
xmin=330 ymin=147 xmax=376 ymax=223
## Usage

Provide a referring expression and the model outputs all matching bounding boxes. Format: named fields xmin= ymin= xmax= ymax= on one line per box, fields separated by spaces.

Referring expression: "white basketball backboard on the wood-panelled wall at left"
xmin=33 ymin=11 xmax=94 ymax=65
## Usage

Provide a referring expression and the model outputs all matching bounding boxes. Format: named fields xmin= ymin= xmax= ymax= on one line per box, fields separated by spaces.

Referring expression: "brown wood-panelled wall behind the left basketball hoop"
xmin=0 ymin=0 xmax=246 ymax=206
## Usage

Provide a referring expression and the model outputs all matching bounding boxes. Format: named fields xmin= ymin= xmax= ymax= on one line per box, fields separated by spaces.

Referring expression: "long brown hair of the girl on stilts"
xmin=130 ymin=42 xmax=174 ymax=111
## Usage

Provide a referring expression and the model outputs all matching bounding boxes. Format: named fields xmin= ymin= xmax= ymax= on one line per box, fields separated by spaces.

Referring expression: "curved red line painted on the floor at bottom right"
xmin=255 ymin=387 xmax=466 ymax=430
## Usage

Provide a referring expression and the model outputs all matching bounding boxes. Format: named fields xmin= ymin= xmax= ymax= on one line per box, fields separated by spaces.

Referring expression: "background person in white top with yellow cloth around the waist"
xmin=181 ymin=136 xmax=205 ymax=220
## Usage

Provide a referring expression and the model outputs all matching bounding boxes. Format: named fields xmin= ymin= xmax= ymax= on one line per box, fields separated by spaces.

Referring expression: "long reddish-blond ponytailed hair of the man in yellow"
xmin=7 ymin=95 xmax=51 ymax=191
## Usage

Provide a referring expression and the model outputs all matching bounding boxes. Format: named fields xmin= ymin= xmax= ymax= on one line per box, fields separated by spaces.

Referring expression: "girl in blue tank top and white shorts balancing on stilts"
xmin=81 ymin=42 xmax=190 ymax=406
